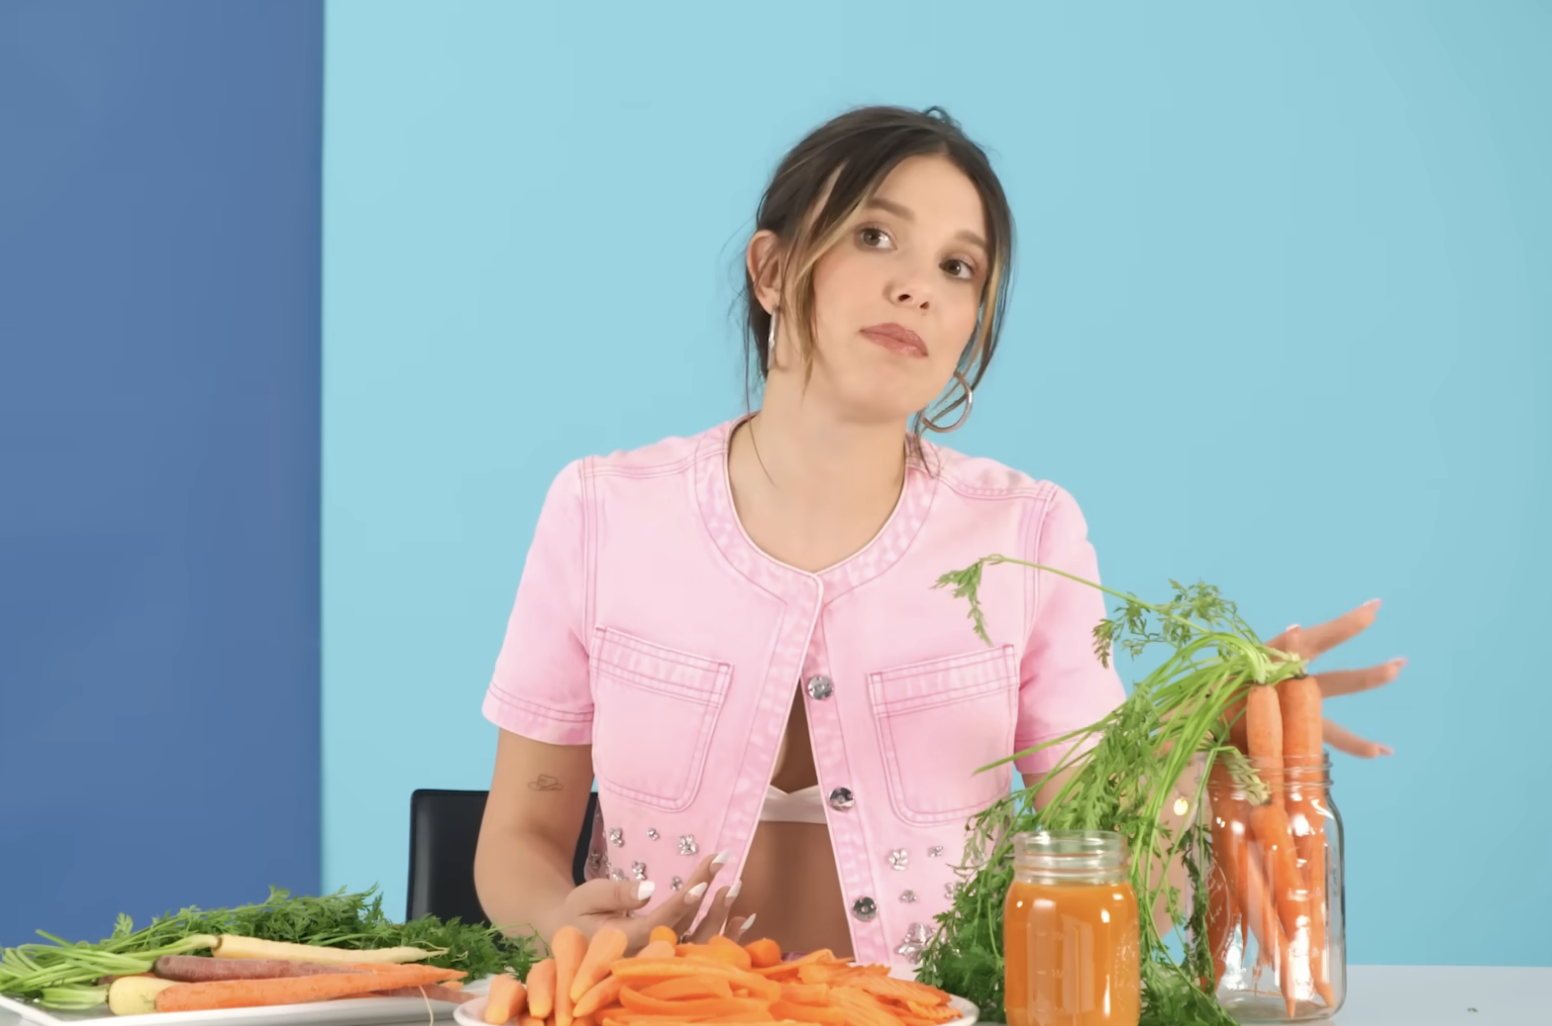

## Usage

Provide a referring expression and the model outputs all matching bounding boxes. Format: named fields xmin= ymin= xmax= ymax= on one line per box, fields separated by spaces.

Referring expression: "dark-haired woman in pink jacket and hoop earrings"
xmin=475 ymin=107 xmax=1398 ymax=964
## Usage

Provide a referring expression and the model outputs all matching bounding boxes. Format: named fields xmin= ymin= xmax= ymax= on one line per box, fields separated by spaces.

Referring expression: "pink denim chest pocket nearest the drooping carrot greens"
xmin=868 ymin=646 xmax=1018 ymax=824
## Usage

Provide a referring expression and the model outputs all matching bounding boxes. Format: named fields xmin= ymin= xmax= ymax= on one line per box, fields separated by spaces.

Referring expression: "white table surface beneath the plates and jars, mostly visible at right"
xmin=0 ymin=965 xmax=1552 ymax=1026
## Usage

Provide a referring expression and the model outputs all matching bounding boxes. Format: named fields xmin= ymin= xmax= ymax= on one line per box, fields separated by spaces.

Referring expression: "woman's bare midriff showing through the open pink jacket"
xmin=733 ymin=682 xmax=852 ymax=958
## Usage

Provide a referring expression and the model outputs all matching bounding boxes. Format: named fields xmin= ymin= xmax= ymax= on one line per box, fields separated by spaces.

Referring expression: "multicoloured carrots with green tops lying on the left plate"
xmin=0 ymin=888 xmax=537 ymax=1014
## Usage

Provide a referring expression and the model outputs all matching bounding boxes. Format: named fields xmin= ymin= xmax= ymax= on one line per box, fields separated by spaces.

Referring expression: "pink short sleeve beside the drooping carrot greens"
xmin=1013 ymin=489 xmax=1127 ymax=776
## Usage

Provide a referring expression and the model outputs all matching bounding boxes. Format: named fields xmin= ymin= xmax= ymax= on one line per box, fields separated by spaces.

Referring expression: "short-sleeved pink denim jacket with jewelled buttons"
xmin=484 ymin=421 xmax=1125 ymax=965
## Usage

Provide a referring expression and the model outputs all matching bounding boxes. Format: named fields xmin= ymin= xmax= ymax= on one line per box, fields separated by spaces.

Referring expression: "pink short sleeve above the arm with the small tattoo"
xmin=483 ymin=463 xmax=593 ymax=745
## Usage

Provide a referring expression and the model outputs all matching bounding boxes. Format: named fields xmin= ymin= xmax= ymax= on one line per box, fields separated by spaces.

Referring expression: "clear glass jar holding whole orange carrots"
xmin=1201 ymin=754 xmax=1347 ymax=1023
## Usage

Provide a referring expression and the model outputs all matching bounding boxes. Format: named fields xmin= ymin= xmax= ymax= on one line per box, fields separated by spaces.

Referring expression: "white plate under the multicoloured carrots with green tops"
xmin=0 ymin=979 xmax=490 ymax=1026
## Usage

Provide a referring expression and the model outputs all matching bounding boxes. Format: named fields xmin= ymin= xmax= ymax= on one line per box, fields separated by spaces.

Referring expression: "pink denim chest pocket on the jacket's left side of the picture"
xmin=591 ymin=627 xmax=733 ymax=812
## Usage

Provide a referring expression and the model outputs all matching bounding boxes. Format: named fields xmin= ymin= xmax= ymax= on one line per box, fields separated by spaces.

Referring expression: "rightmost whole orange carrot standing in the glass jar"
xmin=1277 ymin=677 xmax=1336 ymax=1007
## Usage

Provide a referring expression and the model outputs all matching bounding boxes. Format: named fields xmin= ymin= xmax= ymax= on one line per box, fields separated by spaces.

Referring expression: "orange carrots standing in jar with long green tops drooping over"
xmin=919 ymin=556 xmax=1333 ymax=1026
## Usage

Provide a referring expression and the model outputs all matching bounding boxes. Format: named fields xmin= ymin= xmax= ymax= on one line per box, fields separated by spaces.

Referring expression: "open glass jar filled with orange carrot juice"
xmin=1003 ymin=830 xmax=1142 ymax=1026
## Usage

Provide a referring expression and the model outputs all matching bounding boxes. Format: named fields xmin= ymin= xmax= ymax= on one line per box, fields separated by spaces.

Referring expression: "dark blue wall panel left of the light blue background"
xmin=0 ymin=0 xmax=323 ymax=944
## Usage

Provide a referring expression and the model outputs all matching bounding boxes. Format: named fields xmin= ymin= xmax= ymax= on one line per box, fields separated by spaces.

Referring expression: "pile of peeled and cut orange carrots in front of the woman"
xmin=483 ymin=927 xmax=959 ymax=1026
